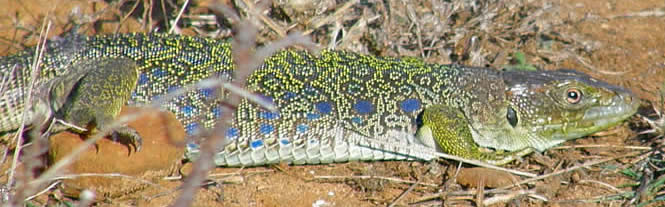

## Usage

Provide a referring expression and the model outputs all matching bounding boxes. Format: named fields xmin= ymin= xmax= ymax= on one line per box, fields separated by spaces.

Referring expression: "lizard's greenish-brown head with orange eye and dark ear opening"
xmin=466 ymin=69 xmax=639 ymax=151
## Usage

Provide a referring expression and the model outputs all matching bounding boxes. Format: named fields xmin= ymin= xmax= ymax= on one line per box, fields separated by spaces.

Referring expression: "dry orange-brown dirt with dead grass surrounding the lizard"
xmin=0 ymin=0 xmax=665 ymax=206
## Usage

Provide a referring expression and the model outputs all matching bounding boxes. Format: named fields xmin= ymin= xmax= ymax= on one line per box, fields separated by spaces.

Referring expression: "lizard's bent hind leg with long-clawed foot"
xmin=56 ymin=58 xmax=143 ymax=151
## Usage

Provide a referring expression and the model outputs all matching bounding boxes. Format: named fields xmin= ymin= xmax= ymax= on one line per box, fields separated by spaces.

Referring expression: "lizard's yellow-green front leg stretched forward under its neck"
xmin=416 ymin=104 xmax=533 ymax=165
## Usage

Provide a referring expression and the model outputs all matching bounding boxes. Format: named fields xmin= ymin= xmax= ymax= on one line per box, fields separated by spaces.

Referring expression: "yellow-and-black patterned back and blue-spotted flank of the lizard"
xmin=0 ymin=33 xmax=472 ymax=164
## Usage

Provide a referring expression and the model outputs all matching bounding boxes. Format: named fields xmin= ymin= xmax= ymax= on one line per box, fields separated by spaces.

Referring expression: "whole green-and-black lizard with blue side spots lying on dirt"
xmin=0 ymin=34 xmax=638 ymax=166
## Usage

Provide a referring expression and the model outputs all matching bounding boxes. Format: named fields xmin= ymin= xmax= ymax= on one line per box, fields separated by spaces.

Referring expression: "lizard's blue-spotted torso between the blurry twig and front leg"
xmin=216 ymin=50 xmax=471 ymax=166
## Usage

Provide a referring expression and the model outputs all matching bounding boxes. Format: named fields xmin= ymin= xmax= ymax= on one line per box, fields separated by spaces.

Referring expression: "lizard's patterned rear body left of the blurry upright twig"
xmin=0 ymin=33 xmax=234 ymax=134
